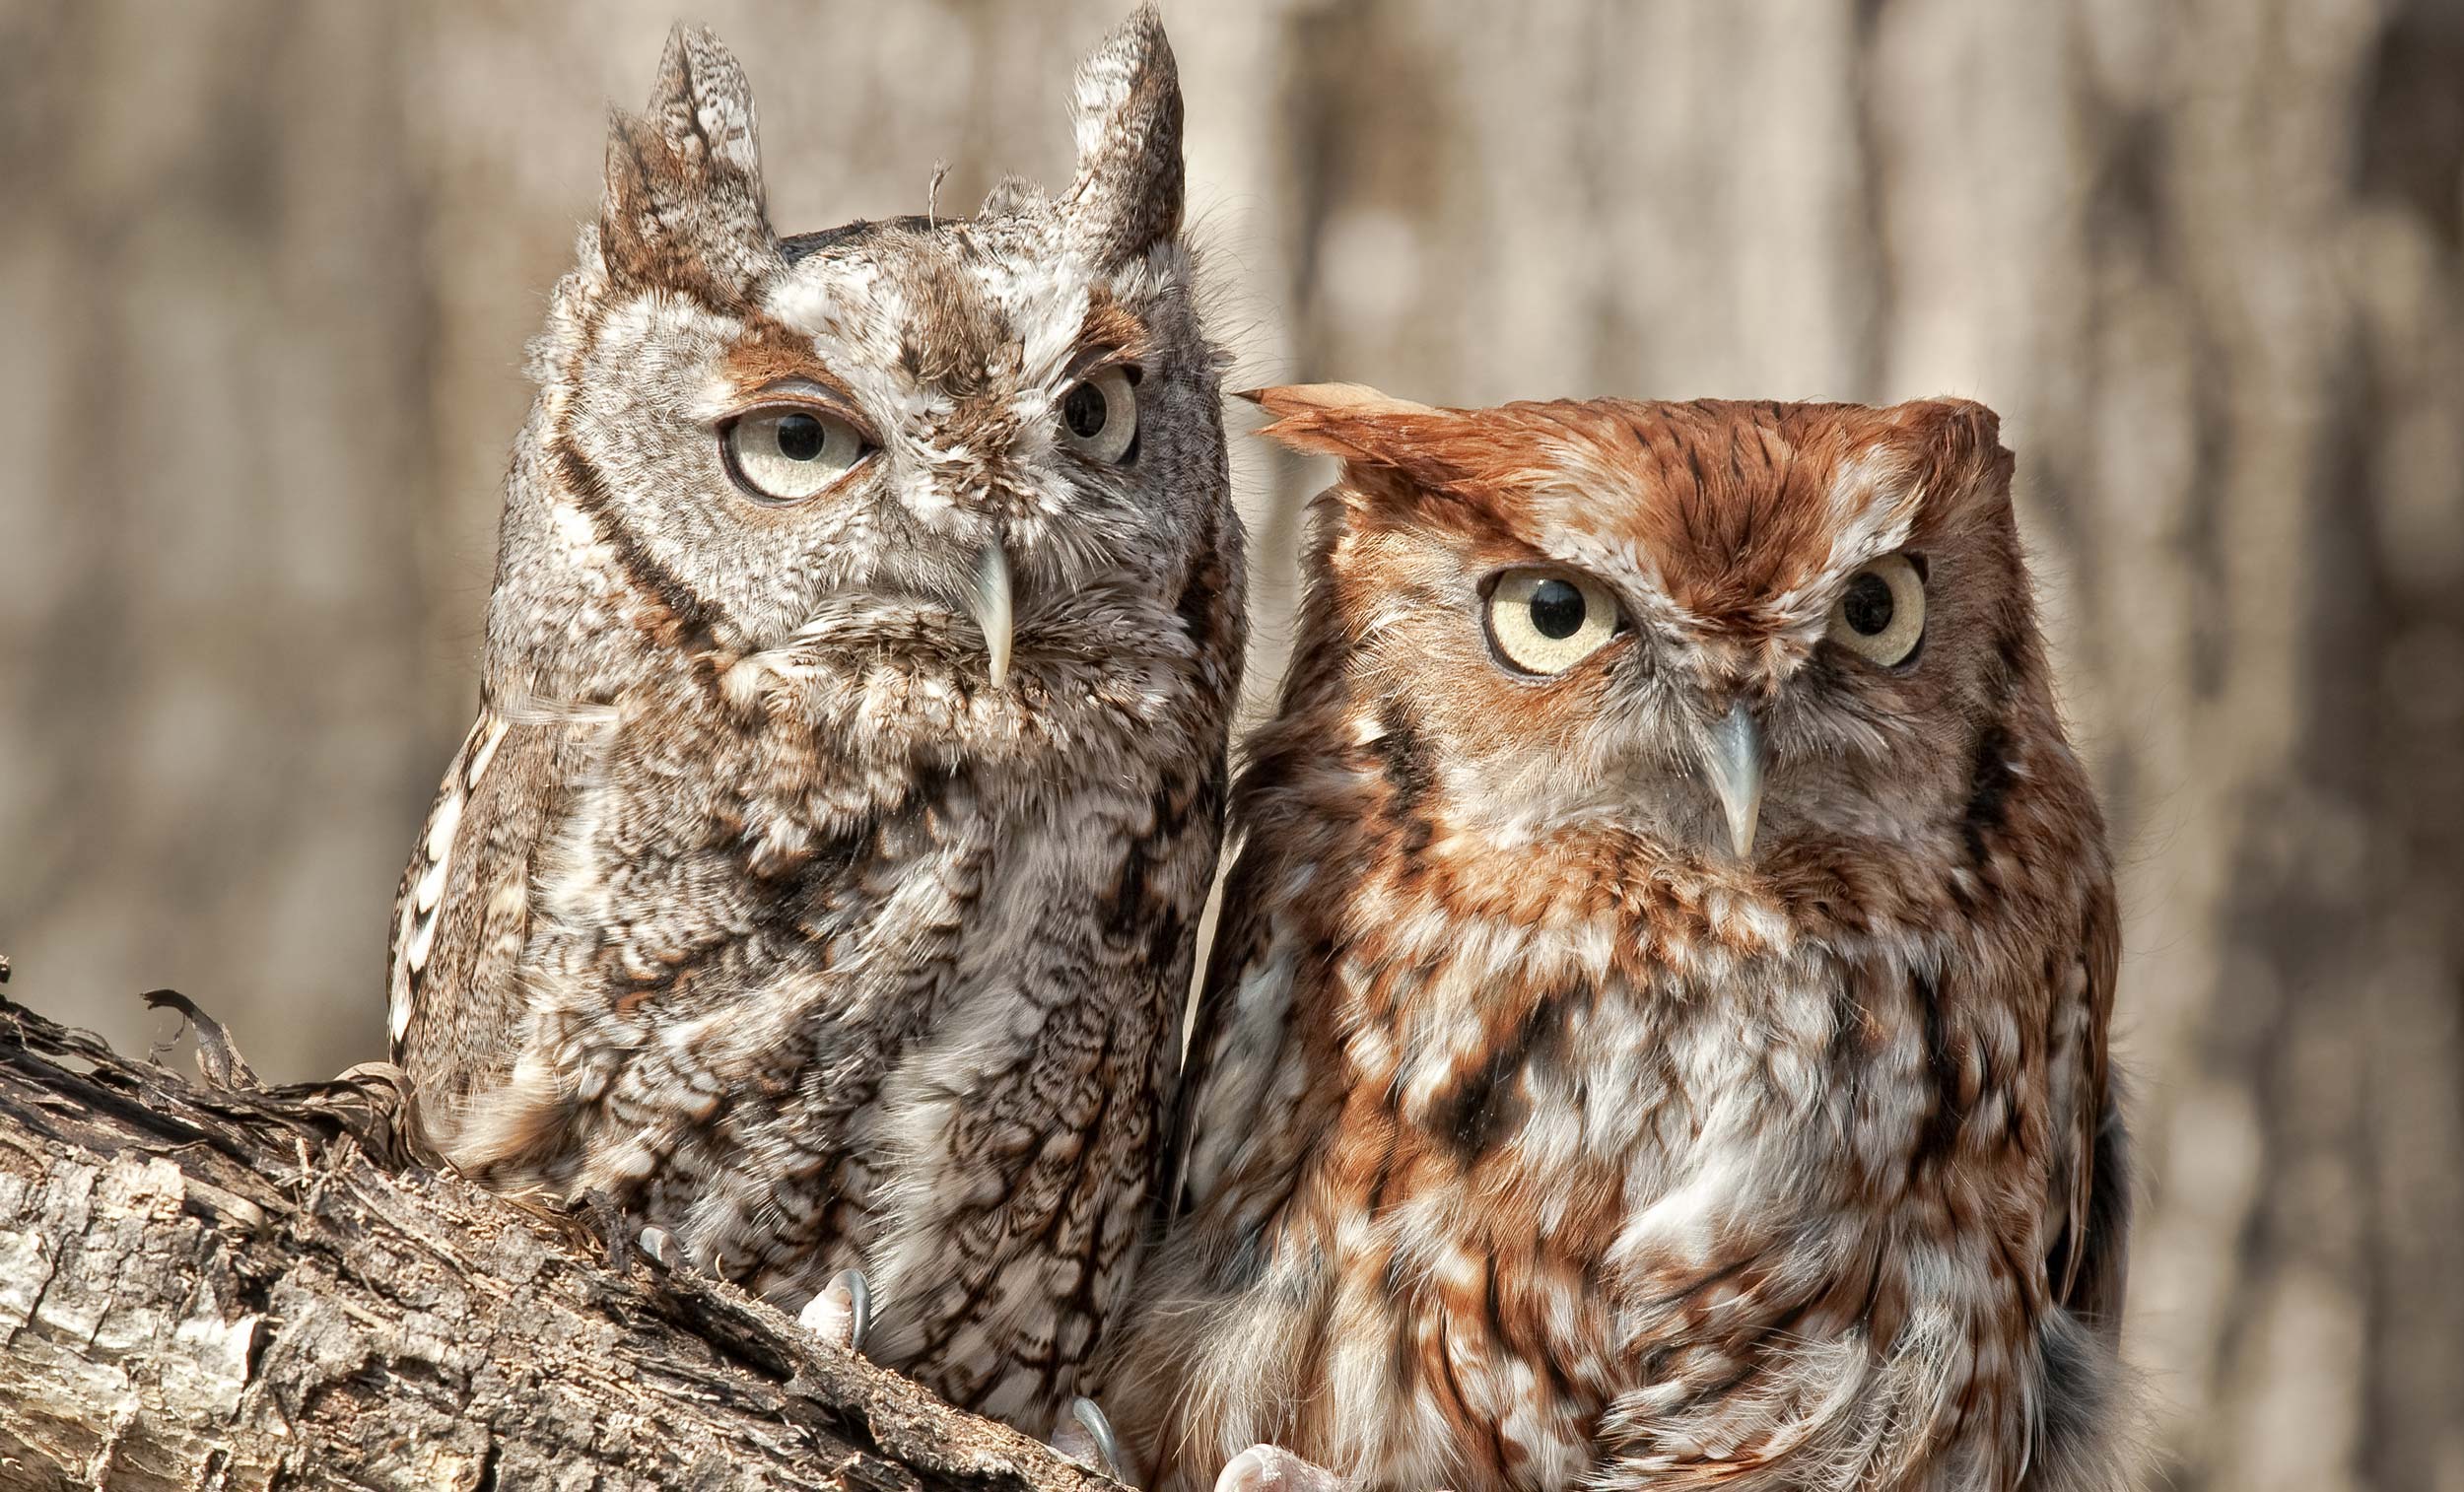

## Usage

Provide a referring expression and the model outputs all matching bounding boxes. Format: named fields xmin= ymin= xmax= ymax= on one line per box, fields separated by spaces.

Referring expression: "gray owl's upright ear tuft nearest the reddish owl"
xmin=1062 ymin=0 xmax=1183 ymax=268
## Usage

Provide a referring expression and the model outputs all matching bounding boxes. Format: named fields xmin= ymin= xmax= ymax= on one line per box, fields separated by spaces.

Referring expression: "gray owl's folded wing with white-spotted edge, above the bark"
xmin=387 ymin=710 xmax=567 ymax=1120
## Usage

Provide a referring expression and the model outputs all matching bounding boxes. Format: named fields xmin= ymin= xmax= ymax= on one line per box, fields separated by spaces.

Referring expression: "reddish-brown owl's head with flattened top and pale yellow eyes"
xmin=1255 ymin=384 xmax=2050 ymax=864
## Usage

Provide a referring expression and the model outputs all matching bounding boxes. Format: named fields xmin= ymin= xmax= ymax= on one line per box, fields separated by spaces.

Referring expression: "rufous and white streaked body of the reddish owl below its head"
xmin=1109 ymin=709 xmax=2119 ymax=1490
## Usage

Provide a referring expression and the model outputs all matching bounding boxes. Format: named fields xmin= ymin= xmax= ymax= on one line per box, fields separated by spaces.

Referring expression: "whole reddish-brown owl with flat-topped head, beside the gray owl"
xmin=1107 ymin=386 xmax=2127 ymax=1492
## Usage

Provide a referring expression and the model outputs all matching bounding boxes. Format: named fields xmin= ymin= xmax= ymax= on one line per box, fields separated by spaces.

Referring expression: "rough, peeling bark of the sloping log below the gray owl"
xmin=0 ymin=999 xmax=1107 ymax=1492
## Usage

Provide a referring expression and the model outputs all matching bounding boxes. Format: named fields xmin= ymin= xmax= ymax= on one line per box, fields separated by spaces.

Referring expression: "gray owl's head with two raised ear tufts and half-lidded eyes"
xmin=493 ymin=7 xmax=1235 ymax=738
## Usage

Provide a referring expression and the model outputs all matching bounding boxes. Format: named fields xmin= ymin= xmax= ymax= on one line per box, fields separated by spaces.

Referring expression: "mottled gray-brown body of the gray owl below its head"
xmin=392 ymin=574 xmax=1240 ymax=1421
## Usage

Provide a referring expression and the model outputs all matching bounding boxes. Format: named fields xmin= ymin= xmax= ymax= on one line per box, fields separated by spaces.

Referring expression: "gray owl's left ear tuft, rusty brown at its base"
xmin=599 ymin=25 xmax=779 ymax=301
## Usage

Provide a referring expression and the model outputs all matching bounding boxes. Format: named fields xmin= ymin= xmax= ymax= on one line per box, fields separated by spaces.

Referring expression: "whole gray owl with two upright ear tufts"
xmin=389 ymin=7 xmax=1245 ymax=1428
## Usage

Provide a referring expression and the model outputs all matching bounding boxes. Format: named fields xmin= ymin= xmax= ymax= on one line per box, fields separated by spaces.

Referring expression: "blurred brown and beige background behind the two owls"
xmin=0 ymin=0 xmax=2464 ymax=1492
